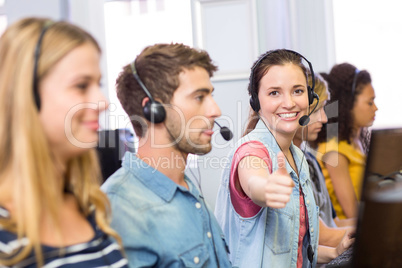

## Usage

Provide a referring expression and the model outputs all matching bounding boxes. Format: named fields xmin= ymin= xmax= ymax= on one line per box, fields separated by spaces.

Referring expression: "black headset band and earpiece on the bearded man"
xmin=131 ymin=60 xmax=166 ymax=124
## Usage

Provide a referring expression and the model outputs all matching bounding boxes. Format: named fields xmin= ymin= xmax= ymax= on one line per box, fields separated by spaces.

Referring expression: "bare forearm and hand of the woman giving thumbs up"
xmin=238 ymin=152 xmax=294 ymax=208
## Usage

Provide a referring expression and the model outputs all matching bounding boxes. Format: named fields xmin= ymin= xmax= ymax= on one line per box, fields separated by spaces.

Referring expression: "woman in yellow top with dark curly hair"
xmin=317 ymin=63 xmax=378 ymax=219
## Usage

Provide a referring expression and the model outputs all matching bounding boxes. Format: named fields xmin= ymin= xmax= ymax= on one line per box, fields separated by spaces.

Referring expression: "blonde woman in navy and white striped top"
xmin=0 ymin=18 xmax=127 ymax=267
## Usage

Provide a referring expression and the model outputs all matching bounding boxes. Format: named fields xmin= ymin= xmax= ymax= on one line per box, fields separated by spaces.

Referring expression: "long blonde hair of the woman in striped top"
xmin=0 ymin=18 xmax=120 ymax=266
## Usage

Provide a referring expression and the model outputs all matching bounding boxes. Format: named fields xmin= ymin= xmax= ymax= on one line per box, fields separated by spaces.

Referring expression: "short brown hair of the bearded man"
xmin=116 ymin=44 xmax=217 ymax=137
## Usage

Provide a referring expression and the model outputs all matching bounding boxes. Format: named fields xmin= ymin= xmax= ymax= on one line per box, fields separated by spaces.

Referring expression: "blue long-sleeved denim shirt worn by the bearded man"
xmin=102 ymin=152 xmax=231 ymax=267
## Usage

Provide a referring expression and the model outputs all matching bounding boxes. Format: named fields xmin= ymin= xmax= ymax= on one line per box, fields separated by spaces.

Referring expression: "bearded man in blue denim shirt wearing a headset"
xmin=102 ymin=44 xmax=231 ymax=267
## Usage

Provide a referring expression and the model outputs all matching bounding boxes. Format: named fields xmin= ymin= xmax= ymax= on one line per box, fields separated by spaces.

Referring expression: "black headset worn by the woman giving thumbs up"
xmin=248 ymin=49 xmax=319 ymax=126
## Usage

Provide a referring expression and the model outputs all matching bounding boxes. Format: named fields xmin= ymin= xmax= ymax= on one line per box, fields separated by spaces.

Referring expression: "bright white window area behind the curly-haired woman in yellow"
xmin=328 ymin=0 xmax=402 ymax=128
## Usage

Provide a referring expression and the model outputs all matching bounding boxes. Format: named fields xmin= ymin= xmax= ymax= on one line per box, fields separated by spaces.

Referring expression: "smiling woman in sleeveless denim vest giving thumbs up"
xmin=215 ymin=49 xmax=318 ymax=267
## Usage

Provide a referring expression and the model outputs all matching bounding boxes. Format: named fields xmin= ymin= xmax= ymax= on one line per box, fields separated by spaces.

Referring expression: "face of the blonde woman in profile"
xmin=40 ymin=43 xmax=107 ymax=159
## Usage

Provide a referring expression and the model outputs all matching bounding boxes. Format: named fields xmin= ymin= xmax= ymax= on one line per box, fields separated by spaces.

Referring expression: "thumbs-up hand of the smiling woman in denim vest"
xmin=265 ymin=152 xmax=295 ymax=208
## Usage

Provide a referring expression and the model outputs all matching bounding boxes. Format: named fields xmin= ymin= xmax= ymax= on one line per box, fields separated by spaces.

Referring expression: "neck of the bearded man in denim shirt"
xmin=137 ymin=128 xmax=188 ymax=188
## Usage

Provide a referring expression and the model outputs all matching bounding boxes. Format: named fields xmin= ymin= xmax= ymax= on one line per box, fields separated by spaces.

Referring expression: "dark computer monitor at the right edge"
xmin=352 ymin=128 xmax=402 ymax=268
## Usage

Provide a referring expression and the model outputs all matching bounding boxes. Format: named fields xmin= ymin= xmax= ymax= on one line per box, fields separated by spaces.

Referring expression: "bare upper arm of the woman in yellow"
xmin=323 ymin=152 xmax=357 ymax=218
